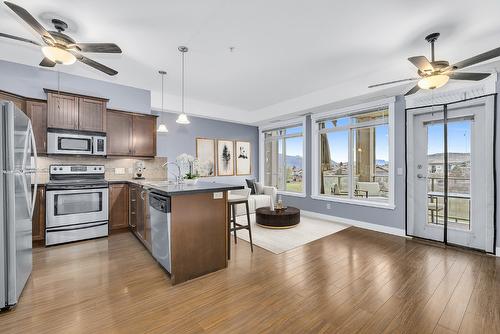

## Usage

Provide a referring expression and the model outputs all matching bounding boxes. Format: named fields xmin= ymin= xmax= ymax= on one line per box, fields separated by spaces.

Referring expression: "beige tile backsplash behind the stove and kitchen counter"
xmin=37 ymin=156 xmax=167 ymax=183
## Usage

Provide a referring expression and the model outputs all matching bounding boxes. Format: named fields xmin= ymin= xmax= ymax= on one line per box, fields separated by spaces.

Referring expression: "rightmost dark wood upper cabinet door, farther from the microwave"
xmin=132 ymin=115 xmax=156 ymax=157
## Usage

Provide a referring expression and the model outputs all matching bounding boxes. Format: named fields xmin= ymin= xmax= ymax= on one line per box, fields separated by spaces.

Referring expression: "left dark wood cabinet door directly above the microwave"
xmin=47 ymin=93 xmax=78 ymax=130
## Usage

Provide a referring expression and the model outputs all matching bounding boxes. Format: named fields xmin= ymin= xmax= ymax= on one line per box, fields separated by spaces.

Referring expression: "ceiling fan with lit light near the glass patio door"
xmin=368 ymin=32 xmax=500 ymax=95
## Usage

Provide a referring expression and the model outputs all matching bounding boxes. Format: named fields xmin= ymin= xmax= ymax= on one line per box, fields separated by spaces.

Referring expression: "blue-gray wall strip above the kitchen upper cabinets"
xmin=0 ymin=60 xmax=151 ymax=114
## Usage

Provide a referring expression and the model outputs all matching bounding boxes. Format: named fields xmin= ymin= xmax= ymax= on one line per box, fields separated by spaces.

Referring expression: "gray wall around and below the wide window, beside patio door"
xmin=283 ymin=97 xmax=405 ymax=229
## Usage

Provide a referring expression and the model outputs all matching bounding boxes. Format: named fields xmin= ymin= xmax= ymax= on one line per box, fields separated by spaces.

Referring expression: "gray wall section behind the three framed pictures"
xmin=153 ymin=111 xmax=259 ymax=185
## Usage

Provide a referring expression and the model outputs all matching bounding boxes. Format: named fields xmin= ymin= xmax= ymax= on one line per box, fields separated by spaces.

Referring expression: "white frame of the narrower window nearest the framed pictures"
xmin=259 ymin=116 xmax=308 ymax=197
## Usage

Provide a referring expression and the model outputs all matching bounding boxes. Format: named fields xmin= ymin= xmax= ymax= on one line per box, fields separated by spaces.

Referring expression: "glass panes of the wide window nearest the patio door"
xmin=315 ymin=108 xmax=391 ymax=203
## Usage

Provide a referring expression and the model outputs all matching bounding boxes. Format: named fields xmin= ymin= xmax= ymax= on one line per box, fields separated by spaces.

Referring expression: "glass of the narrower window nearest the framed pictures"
xmin=264 ymin=125 xmax=304 ymax=193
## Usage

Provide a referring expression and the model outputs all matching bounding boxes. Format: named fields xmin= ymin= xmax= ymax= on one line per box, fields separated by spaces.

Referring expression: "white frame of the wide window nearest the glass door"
xmin=311 ymin=97 xmax=396 ymax=210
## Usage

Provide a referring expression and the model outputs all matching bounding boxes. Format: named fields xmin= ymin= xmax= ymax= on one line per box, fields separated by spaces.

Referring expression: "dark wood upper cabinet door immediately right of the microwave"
xmin=106 ymin=110 xmax=133 ymax=156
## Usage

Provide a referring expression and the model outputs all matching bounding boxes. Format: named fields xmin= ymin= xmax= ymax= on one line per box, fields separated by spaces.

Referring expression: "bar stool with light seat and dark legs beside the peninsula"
xmin=227 ymin=189 xmax=253 ymax=259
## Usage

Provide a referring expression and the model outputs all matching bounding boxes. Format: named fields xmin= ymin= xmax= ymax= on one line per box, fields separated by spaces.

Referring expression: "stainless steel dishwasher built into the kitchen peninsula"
xmin=149 ymin=191 xmax=172 ymax=273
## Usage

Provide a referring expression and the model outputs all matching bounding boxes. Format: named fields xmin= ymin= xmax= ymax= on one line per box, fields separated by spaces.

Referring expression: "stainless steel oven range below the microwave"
xmin=45 ymin=165 xmax=108 ymax=246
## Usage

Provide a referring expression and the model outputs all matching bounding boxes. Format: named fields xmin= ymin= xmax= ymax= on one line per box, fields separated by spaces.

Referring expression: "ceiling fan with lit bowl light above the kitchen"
xmin=0 ymin=1 xmax=122 ymax=75
